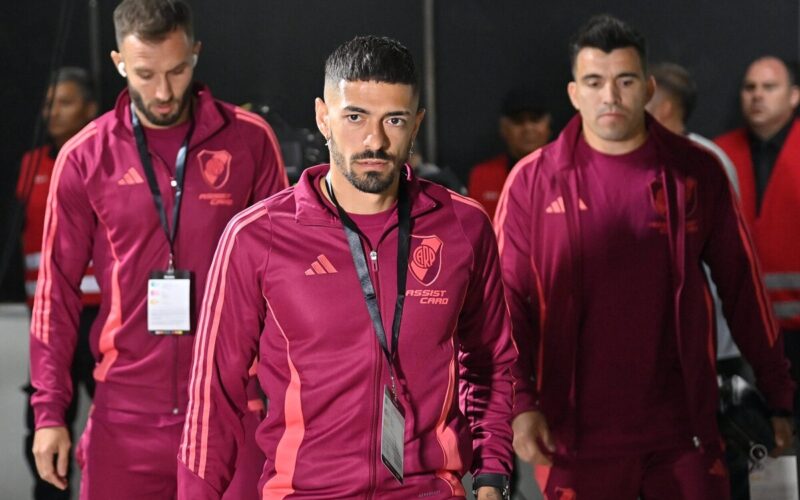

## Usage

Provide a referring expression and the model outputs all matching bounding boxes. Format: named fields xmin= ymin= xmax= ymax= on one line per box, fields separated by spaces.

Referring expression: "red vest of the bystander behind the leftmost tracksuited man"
xmin=17 ymin=146 xmax=100 ymax=307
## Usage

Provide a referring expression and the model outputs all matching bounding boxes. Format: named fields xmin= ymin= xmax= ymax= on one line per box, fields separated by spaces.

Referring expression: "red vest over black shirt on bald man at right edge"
xmin=715 ymin=120 xmax=800 ymax=330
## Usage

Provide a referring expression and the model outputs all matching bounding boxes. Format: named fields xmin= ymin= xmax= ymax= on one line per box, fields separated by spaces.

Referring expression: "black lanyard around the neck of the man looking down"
xmin=131 ymin=104 xmax=194 ymax=272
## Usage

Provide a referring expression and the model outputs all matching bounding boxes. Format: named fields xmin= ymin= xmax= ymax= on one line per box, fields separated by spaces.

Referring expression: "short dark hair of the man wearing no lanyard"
xmin=569 ymin=14 xmax=647 ymax=72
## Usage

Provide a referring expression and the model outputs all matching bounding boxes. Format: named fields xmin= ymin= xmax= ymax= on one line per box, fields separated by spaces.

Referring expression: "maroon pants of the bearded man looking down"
xmin=76 ymin=411 xmax=264 ymax=500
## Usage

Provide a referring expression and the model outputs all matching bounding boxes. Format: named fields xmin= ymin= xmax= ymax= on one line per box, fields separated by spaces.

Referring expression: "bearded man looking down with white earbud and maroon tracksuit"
xmin=31 ymin=0 xmax=287 ymax=499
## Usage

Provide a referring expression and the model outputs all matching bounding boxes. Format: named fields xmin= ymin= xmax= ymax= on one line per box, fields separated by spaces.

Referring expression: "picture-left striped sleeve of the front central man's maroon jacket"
xmin=178 ymin=204 xmax=268 ymax=500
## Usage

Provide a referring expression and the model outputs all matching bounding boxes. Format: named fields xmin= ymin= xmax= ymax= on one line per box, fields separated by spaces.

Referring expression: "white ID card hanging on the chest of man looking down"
xmin=147 ymin=271 xmax=192 ymax=335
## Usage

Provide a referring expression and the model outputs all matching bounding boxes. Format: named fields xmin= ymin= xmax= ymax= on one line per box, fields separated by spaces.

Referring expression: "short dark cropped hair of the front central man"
xmin=325 ymin=35 xmax=419 ymax=95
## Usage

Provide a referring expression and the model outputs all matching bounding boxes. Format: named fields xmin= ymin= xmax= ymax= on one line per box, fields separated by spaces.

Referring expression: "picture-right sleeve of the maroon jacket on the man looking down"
xmin=244 ymin=113 xmax=289 ymax=204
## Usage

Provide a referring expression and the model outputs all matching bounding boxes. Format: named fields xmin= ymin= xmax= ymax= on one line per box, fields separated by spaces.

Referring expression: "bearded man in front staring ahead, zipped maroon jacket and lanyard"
xmin=178 ymin=36 xmax=515 ymax=500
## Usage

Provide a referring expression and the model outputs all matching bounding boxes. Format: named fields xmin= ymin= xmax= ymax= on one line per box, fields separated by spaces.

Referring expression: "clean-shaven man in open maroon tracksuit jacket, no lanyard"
xmin=495 ymin=16 xmax=792 ymax=500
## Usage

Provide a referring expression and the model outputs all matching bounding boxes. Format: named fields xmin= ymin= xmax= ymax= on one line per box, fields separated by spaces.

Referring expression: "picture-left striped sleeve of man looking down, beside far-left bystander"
xmin=30 ymin=140 xmax=96 ymax=429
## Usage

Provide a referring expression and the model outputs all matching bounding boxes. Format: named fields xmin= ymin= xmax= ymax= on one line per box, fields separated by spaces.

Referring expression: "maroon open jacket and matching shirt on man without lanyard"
xmin=495 ymin=116 xmax=792 ymax=498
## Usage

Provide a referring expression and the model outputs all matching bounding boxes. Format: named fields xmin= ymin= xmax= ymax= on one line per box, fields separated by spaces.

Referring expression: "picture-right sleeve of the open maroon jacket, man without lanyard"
xmin=703 ymin=162 xmax=794 ymax=412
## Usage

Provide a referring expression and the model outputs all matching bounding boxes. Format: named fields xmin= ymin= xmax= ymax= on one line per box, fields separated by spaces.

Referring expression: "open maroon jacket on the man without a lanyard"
xmin=495 ymin=116 xmax=793 ymax=452
